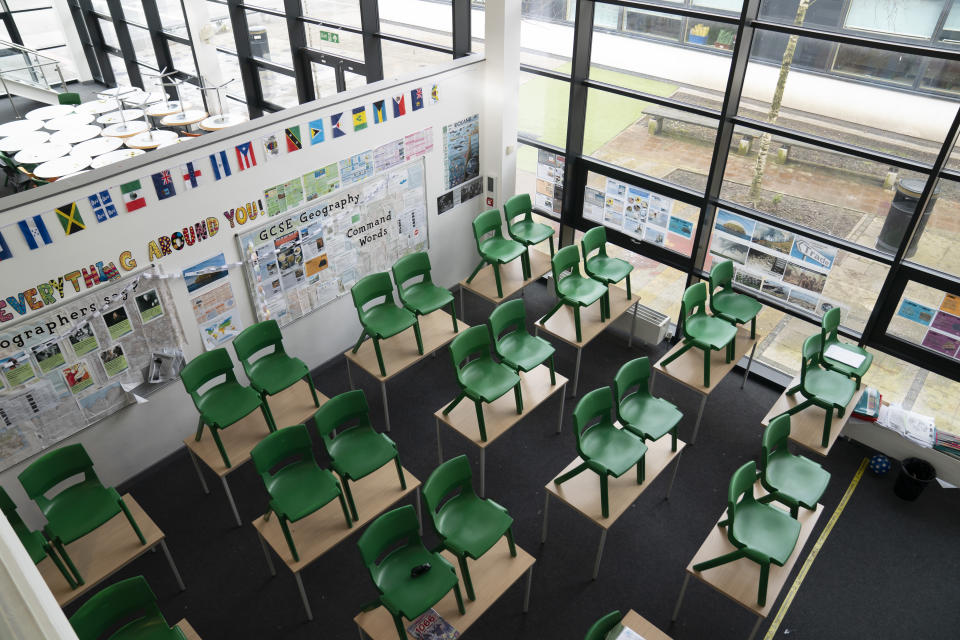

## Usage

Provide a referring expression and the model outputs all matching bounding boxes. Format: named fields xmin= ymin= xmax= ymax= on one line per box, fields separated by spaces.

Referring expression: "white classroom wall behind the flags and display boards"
xmin=0 ymin=56 xmax=489 ymax=526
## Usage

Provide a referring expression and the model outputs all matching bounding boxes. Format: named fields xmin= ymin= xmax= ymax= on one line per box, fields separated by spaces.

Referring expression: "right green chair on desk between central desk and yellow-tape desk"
xmin=613 ymin=356 xmax=683 ymax=451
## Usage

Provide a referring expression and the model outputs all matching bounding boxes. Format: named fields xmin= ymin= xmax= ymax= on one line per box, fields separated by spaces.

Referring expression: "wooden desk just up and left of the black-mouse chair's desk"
xmin=253 ymin=462 xmax=423 ymax=620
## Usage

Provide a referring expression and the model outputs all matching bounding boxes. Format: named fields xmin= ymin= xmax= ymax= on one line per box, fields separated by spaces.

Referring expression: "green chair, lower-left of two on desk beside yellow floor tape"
xmin=693 ymin=460 xmax=800 ymax=607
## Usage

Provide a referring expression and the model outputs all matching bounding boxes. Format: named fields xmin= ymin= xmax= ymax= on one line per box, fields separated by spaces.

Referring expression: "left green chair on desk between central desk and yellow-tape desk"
xmin=553 ymin=387 xmax=647 ymax=518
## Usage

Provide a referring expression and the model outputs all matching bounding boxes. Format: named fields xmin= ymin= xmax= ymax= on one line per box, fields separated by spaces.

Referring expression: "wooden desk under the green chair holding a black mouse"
xmin=353 ymin=538 xmax=536 ymax=640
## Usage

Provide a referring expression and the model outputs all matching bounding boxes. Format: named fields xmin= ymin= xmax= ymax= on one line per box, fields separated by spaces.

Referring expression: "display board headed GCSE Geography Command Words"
xmin=237 ymin=152 xmax=429 ymax=326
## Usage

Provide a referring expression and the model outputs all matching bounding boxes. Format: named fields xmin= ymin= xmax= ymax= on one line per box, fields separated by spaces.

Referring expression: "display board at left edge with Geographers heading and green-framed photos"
xmin=0 ymin=270 xmax=183 ymax=469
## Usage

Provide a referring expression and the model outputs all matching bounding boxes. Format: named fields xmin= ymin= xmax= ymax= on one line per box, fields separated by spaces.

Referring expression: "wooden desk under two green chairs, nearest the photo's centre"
xmin=433 ymin=364 xmax=567 ymax=497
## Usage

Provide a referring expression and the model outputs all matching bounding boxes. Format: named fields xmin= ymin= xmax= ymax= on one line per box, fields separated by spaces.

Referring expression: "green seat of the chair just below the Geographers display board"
xmin=44 ymin=480 xmax=120 ymax=544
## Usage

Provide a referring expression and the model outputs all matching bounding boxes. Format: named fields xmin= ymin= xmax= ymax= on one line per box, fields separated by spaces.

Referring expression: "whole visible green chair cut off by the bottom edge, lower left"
xmin=70 ymin=576 xmax=186 ymax=640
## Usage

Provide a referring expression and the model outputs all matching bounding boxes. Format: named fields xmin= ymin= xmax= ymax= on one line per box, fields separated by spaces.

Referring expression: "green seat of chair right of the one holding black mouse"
xmin=436 ymin=493 xmax=513 ymax=560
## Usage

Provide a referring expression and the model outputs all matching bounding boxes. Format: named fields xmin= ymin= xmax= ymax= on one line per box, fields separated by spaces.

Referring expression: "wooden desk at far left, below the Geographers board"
xmin=37 ymin=493 xmax=186 ymax=607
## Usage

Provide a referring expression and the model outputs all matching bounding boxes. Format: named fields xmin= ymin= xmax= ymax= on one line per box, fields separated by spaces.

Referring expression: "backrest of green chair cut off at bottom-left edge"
xmin=70 ymin=576 xmax=169 ymax=640
